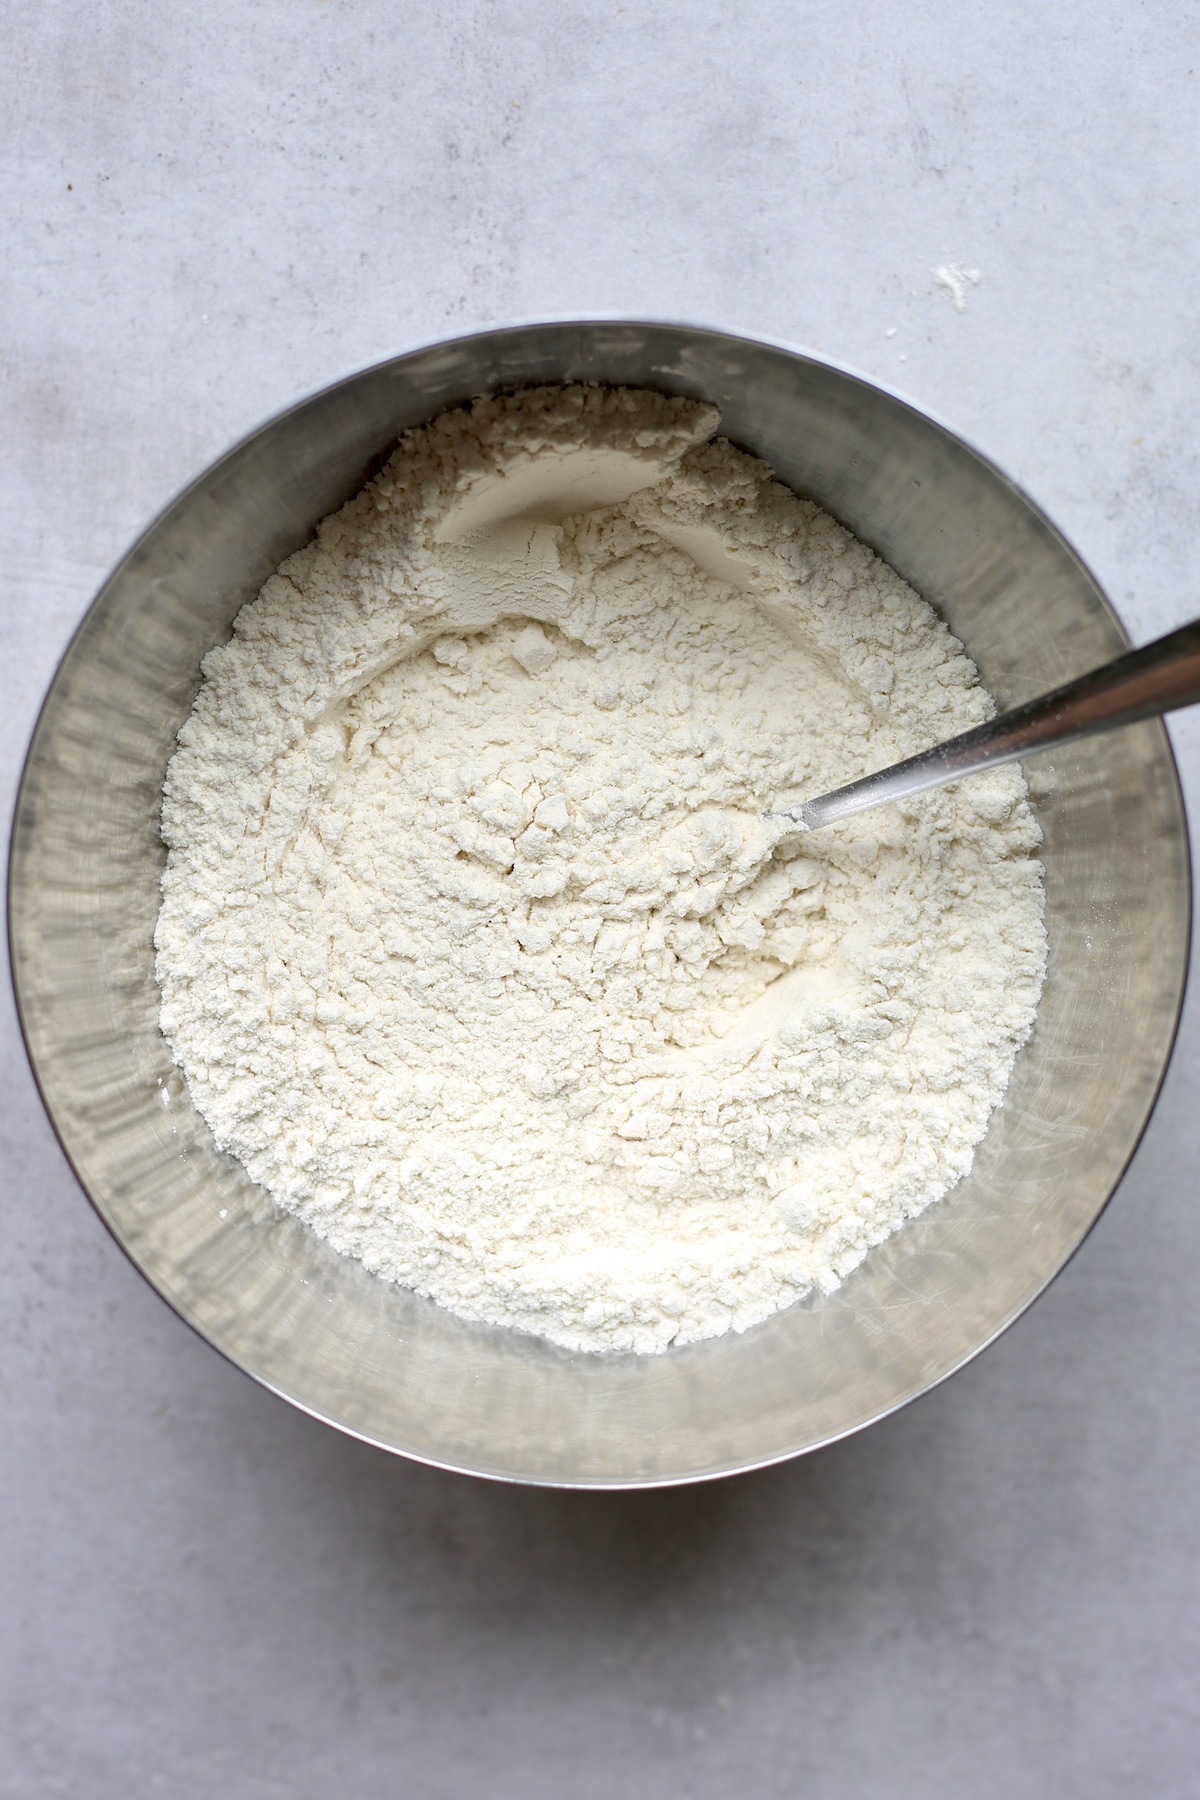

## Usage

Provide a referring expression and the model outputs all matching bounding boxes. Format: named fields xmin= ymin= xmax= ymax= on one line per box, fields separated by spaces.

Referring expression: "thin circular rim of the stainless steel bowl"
xmin=5 ymin=311 xmax=1196 ymax=1492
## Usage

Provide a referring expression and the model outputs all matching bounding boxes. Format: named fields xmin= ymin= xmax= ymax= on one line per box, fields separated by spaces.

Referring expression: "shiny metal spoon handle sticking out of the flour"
xmin=772 ymin=619 xmax=1200 ymax=832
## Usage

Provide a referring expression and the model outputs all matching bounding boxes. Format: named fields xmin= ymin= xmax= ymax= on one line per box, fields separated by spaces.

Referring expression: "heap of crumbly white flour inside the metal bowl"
xmin=157 ymin=389 xmax=1045 ymax=1350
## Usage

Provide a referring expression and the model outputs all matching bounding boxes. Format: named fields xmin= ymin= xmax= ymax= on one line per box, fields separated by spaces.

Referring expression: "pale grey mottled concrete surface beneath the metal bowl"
xmin=0 ymin=0 xmax=1200 ymax=1800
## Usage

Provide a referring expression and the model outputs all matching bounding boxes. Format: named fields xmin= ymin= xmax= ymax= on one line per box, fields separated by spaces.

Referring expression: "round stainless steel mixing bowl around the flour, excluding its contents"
xmin=9 ymin=322 xmax=1189 ymax=1487
